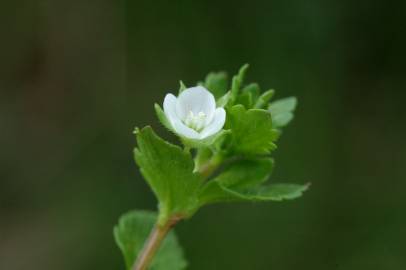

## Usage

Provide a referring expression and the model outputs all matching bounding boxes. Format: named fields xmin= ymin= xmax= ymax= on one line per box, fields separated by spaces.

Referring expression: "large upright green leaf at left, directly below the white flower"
xmin=134 ymin=127 xmax=201 ymax=224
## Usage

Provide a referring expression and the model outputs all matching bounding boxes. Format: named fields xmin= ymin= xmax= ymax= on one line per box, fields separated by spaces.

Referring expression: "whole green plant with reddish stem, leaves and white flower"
xmin=114 ymin=65 xmax=308 ymax=270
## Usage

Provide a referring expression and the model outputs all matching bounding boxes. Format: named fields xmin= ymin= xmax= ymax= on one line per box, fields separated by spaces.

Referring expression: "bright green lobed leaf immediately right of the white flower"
xmin=226 ymin=105 xmax=276 ymax=155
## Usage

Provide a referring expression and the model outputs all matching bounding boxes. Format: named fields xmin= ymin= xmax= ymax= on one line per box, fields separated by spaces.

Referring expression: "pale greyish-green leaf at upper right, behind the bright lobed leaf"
xmin=269 ymin=97 xmax=297 ymax=128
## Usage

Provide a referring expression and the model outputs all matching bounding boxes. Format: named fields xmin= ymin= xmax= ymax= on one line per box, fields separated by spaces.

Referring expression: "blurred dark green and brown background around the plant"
xmin=0 ymin=0 xmax=406 ymax=270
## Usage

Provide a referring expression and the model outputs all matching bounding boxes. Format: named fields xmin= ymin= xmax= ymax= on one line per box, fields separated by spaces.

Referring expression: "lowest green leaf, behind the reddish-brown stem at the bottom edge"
xmin=114 ymin=211 xmax=187 ymax=270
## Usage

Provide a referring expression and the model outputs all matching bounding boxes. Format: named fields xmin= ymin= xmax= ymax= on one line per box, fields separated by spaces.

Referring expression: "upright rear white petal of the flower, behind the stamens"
xmin=176 ymin=86 xmax=216 ymax=124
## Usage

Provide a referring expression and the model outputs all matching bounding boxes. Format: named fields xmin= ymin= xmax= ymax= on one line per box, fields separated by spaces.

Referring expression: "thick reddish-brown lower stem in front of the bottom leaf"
xmin=132 ymin=217 xmax=180 ymax=270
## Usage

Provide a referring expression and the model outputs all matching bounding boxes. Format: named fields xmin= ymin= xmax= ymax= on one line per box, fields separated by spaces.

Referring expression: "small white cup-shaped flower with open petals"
xmin=164 ymin=86 xmax=226 ymax=140
